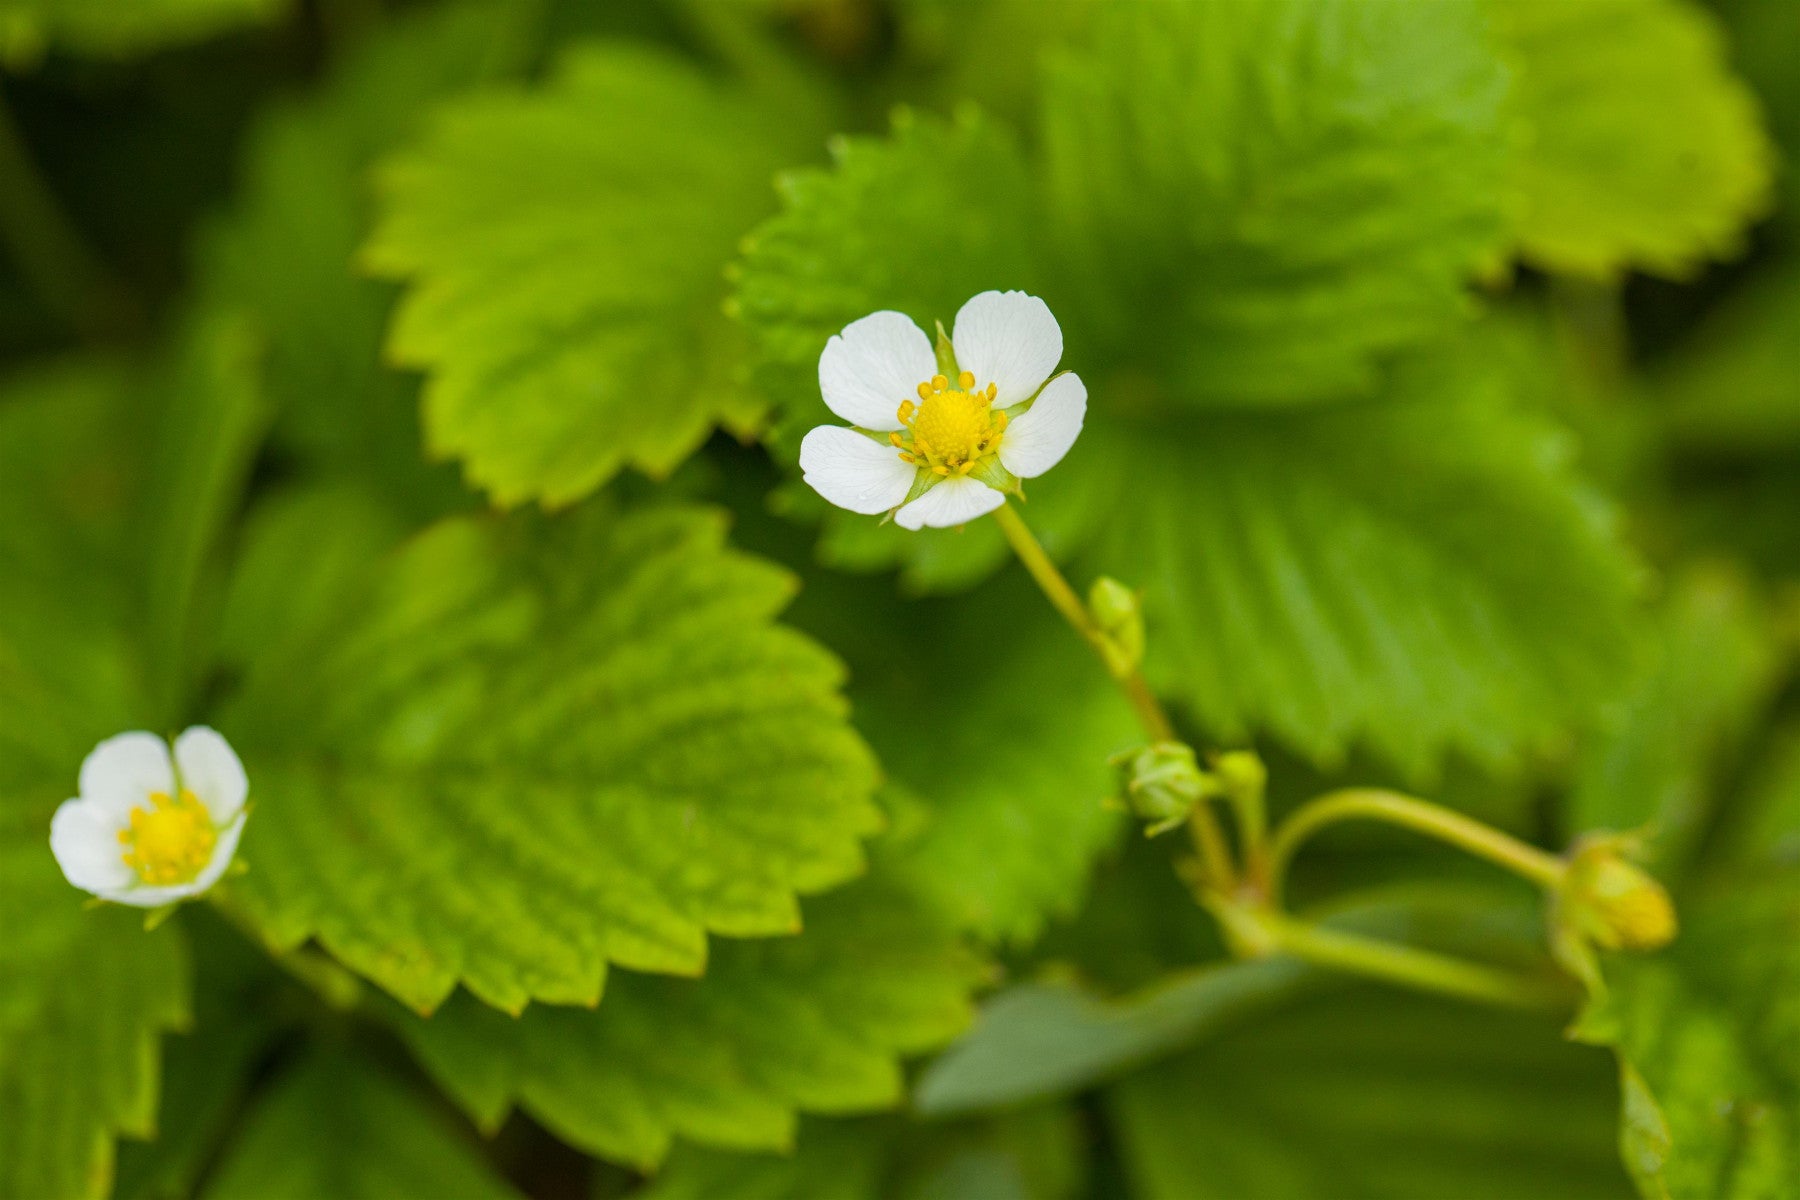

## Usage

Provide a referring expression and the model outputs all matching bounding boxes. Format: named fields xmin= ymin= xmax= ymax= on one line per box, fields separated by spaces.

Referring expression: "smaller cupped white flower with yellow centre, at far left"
xmin=50 ymin=725 xmax=250 ymax=909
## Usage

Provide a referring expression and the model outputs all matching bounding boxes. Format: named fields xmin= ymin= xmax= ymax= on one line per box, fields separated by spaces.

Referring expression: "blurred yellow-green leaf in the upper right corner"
xmin=1490 ymin=0 xmax=1773 ymax=279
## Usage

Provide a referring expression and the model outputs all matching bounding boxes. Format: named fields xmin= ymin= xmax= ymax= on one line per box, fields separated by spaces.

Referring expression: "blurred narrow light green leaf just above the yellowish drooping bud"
xmin=1570 ymin=569 xmax=1780 ymax=876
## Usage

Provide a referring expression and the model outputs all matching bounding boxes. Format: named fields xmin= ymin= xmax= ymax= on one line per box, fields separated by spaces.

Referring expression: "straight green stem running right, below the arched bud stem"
xmin=1260 ymin=912 xmax=1568 ymax=1009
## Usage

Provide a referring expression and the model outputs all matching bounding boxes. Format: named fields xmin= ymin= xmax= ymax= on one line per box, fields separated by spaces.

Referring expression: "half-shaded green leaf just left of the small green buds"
xmin=851 ymin=579 xmax=1143 ymax=943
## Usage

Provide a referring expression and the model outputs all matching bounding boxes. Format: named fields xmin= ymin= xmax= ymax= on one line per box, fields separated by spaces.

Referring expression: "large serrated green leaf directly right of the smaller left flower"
xmin=220 ymin=506 xmax=878 ymax=1011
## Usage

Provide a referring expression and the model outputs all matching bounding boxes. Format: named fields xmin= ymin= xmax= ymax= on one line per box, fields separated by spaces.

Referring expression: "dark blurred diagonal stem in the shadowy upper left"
xmin=0 ymin=85 xmax=130 ymax=338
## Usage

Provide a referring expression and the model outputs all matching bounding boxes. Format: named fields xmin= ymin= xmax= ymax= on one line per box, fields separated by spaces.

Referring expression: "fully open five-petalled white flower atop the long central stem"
xmin=799 ymin=291 xmax=1087 ymax=529
